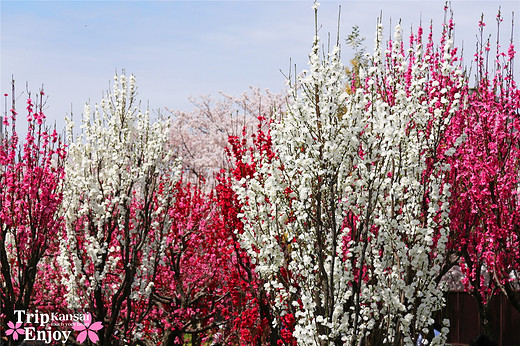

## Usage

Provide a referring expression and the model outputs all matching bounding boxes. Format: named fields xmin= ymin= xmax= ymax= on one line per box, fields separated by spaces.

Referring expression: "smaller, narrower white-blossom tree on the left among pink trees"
xmin=60 ymin=75 xmax=178 ymax=345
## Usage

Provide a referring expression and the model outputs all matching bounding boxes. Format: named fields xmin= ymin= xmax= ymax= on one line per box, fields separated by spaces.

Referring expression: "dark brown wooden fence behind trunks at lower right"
xmin=445 ymin=292 xmax=520 ymax=346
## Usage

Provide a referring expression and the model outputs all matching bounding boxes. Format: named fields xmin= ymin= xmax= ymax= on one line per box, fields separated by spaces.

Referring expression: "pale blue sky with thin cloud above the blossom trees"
xmin=0 ymin=0 xmax=520 ymax=132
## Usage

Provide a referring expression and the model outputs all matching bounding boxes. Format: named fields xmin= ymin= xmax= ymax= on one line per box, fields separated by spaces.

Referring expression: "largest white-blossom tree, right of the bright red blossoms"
xmin=235 ymin=7 xmax=465 ymax=345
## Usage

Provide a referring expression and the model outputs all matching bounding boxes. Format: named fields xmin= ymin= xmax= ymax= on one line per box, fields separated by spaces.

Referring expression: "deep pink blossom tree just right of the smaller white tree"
xmin=145 ymin=183 xmax=232 ymax=345
